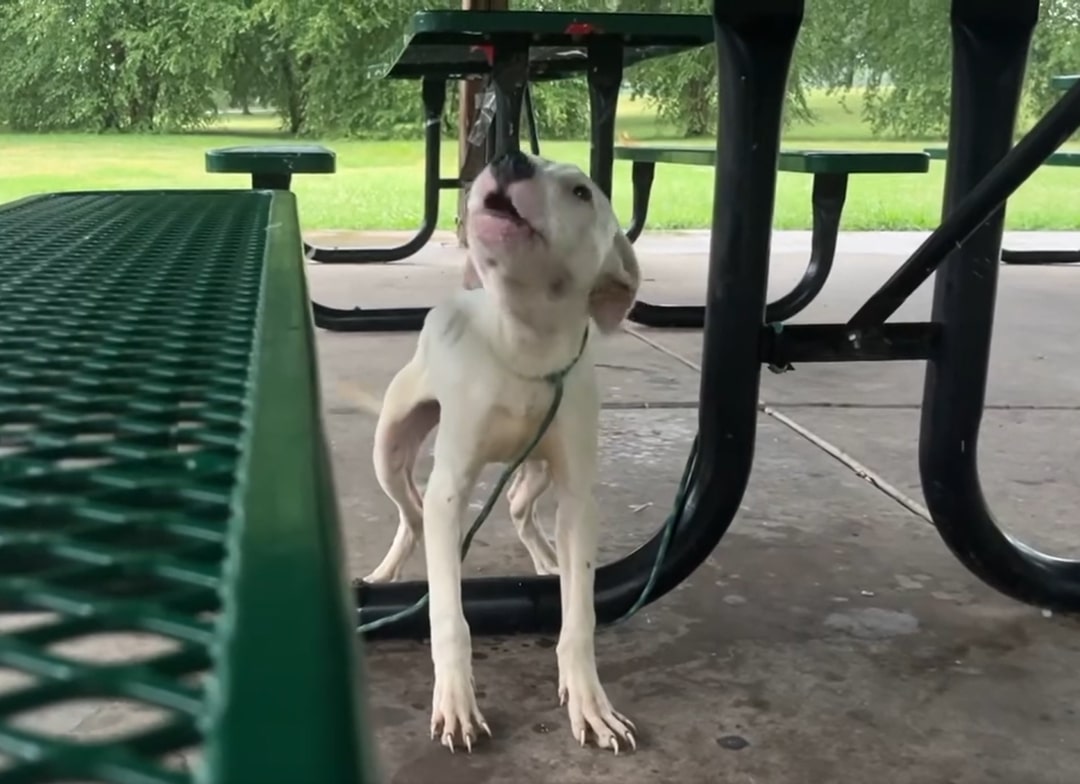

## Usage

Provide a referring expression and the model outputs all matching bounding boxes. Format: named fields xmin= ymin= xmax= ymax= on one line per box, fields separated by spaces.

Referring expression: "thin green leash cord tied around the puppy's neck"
xmin=356 ymin=329 xmax=698 ymax=634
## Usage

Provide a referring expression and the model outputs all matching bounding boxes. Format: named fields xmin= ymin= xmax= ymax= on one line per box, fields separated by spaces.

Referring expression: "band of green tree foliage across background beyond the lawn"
xmin=0 ymin=0 xmax=1080 ymax=137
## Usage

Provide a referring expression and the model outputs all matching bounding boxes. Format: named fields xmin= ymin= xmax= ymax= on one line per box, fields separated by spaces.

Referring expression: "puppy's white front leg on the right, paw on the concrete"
xmin=555 ymin=485 xmax=637 ymax=754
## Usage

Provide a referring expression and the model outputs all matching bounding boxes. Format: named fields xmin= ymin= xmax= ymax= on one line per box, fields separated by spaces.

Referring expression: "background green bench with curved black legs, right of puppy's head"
xmin=615 ymin=145 xmax=930 ymax=329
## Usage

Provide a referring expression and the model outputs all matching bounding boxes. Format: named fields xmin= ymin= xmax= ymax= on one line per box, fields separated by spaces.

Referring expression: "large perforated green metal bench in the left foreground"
xmin=0 ymin=191 xmax=374 ymax=784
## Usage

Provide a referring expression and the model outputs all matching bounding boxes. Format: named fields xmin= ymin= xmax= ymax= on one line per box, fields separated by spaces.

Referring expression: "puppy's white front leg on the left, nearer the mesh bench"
xmin=423 ymin=424 xmax=491 ymax=752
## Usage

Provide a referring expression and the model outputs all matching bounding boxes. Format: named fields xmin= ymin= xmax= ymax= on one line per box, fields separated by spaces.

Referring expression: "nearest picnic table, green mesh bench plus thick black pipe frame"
xmin=0 ymin=0 xmax=1080 ymax=784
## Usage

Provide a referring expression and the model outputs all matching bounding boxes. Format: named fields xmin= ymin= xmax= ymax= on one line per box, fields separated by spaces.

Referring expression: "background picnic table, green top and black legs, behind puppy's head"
xmin=309 ymin=11 xmax=713 ymax=330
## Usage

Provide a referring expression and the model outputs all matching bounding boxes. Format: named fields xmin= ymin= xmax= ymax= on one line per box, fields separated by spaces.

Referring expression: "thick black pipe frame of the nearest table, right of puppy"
xmin=356 ymin=0 xmax=1080 ymax=637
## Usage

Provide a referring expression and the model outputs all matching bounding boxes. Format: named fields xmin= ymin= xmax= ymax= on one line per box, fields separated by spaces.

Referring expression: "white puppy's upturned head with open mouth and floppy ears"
xmin=465 ymin=152 xmax=640 ymax=332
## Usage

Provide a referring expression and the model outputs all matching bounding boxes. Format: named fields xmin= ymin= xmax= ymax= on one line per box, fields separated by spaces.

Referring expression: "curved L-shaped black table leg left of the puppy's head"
xmin=305 ymin=79 xmax=449 ymax=265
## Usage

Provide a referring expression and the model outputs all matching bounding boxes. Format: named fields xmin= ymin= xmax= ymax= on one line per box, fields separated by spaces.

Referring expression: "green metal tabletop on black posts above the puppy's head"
xmin=373 ymin=11 xmax=713 ymax=79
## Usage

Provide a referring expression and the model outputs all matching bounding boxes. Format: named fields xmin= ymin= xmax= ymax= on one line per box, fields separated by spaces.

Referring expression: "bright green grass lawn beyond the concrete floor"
xmin=0 ymin=95 xmax=1080 ymax=230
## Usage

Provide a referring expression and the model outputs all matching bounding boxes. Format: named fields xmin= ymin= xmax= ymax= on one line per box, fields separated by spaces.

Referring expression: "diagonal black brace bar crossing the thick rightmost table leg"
xmin=849 ymin=76 xmax=1080 ymax=326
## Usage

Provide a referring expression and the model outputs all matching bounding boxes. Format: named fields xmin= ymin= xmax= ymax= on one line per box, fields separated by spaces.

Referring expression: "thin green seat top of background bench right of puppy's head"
xmin=615 ymin=145 xmax=930 ymax=174
